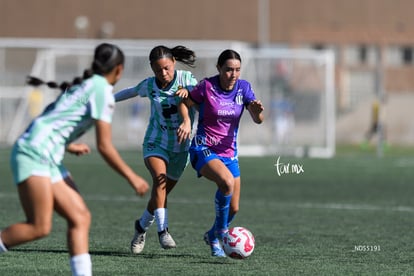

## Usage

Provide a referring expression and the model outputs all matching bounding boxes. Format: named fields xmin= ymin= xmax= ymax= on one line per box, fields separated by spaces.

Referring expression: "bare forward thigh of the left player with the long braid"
xmin=52 ymin=179 xmax=91 ymax=227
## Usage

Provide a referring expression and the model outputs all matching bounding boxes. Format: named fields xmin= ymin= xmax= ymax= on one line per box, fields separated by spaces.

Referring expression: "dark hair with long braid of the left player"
xmin=26 ymin=43 xmax=125 ymax=91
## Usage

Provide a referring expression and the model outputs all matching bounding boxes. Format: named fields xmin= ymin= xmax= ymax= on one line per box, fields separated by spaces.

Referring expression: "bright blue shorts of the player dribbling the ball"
xmin=190 ymin=149 xmax=240 ymax=178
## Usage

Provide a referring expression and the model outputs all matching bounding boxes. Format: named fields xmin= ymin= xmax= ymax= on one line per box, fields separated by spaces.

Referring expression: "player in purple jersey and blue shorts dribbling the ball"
xmin=181 ymin=50 xmax=263 ymax=257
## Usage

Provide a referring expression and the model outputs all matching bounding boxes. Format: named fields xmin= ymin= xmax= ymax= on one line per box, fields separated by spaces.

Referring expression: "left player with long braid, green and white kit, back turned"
xmin=0 ymin=43 xmax=149 ymax=275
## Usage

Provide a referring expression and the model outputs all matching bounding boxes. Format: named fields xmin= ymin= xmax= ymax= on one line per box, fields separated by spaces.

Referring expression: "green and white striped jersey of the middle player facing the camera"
xmin=115 ymin=70 xmax=197 ymax=152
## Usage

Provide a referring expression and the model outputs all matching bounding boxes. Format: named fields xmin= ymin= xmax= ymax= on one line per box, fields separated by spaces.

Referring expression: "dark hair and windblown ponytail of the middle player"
xmin=149 ymin=45 xmax=196 ymax=67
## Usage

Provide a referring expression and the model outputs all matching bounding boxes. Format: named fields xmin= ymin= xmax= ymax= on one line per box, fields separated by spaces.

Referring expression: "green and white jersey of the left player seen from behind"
xmin=17 ymin=75 xmax=115 ymax=164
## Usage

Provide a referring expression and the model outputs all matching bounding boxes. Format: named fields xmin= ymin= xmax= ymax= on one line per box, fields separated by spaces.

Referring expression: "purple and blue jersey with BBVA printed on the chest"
xmin=190 ymin=75 xmax=256 ymax=157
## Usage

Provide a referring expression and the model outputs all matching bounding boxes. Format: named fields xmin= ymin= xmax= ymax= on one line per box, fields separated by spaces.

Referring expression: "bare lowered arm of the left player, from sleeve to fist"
xmin=95 ymin=120 xmax=149 ymax=196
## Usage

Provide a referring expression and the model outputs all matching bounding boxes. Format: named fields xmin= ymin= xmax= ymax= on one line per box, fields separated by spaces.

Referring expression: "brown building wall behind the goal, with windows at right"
xmin=0 ymin=0 xmax=414 ymax=104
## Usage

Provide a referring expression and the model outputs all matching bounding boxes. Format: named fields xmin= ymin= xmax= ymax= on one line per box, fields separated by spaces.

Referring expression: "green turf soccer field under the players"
xmin=0 ymin=146 xmax=414 ymax=276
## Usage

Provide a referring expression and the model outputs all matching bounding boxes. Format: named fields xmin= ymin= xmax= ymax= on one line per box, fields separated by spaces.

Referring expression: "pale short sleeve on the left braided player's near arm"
xmin=90 ymin=86 xmax=115 ymax=123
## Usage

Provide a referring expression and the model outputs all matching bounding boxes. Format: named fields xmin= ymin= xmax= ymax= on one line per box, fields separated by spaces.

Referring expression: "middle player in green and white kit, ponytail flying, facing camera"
xmin=115 ymin=46 xmax=197 ymax=254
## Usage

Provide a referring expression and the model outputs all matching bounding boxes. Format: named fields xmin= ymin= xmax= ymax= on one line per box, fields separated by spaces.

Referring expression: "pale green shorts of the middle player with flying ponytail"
xmin=142 ymin=143 xmax=189 ymax=181
